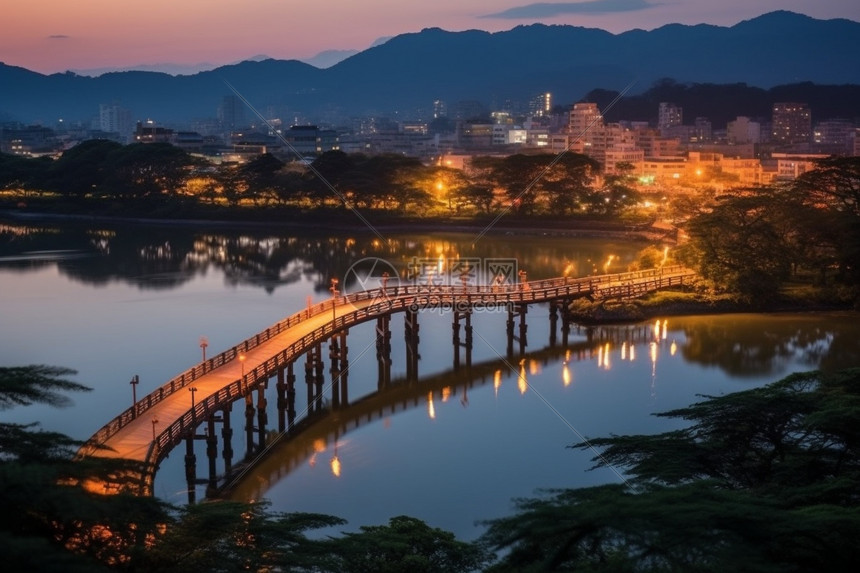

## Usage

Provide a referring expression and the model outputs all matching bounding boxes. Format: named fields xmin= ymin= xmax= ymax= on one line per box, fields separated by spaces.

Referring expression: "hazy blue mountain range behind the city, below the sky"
xmin=0 ymin=11 xmax=860 ymax=124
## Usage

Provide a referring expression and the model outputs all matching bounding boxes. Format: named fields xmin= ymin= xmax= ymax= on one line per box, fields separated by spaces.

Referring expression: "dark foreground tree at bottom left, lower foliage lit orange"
xmin=0 ymin=366 xmax=171 ymax=571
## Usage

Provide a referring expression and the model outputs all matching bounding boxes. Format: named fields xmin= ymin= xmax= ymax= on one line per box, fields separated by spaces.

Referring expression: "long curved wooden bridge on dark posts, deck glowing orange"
xmin=79 ymin=266 xmax=695 ymax=495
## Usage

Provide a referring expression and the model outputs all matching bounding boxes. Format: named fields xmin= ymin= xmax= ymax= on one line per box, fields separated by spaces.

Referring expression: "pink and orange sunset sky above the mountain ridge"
xmin=0 ymin=0 xmax=860 ymax=73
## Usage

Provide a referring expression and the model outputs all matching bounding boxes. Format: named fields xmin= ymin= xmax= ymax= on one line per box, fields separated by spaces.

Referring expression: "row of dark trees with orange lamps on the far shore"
xmin=0 ymin=140 xmax=638 ymax=216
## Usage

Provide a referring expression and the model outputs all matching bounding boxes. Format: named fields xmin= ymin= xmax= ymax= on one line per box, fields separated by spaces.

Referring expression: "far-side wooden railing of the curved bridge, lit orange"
xmin=84 ymin=265 xmax=693 ymax=456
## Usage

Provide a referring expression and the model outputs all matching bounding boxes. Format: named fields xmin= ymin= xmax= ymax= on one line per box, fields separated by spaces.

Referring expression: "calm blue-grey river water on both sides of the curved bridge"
xmin=0 ymin=217 xmax=860 ymax=538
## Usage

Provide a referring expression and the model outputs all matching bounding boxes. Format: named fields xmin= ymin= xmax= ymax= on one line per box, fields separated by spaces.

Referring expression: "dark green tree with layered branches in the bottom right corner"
xmin=483 ymin=369 xmax=860 ymax=572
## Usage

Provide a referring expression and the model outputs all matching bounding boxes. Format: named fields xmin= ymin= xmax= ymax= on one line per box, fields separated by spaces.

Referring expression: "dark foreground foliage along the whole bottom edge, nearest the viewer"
xmin=6 ymin=366 xmax=860 ymax=572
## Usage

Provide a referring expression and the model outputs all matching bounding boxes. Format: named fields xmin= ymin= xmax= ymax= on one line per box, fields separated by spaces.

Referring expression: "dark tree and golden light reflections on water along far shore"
xmin=0 ymin=217 xmax=640 ymax=292
